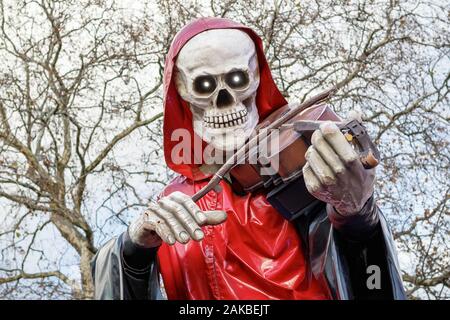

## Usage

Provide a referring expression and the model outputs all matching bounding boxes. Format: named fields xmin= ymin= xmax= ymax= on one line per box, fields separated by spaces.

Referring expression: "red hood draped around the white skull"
xmin=163 ymin=18 xmax=287 ymax=180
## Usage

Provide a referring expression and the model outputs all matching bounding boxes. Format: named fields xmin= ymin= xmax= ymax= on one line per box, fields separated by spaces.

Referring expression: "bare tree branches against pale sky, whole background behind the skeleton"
xmin=0 ymin=0 xmax=450 ymax=299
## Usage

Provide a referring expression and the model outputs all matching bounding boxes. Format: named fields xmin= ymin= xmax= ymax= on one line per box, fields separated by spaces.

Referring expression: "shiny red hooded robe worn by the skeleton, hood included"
xmin=158 ymin=18 xmax=328 ymax=300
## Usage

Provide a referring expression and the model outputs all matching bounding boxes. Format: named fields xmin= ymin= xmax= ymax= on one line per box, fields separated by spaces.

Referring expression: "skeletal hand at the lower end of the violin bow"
xmin=128 ymin=191 xmax=227 ymax=248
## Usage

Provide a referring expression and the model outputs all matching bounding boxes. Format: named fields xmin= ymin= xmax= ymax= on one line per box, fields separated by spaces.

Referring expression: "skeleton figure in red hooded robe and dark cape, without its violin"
xmin=92 ymin=18 xmax=405 ymax=299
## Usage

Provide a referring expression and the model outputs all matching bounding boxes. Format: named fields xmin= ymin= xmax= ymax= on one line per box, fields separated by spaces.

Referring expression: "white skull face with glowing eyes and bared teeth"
xmin=175 ymin=29 xmax=259 ymax=151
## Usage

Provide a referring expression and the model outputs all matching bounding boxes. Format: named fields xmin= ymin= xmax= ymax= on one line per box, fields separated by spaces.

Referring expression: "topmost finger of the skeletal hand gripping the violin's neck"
xmin=320 ymin=122 xmax=358 ymax=164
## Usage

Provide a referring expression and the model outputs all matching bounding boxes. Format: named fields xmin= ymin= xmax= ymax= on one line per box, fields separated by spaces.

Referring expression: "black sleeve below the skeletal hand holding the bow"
xmin=121 ymin=232 xmax=158 ymax=300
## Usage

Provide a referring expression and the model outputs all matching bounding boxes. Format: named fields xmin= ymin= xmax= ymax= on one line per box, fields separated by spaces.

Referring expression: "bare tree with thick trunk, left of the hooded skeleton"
xmin=0 ymin=1 xmax=171 ymax=298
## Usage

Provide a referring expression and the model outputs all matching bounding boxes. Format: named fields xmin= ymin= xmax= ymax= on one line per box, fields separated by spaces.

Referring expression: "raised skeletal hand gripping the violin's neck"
xmin=303 ymin=111 xmax=375 ymax=215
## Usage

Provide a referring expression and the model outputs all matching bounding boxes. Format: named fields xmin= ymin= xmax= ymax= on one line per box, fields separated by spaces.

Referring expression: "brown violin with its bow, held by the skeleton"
xmin=192 ymin=87 xmax=380 ymax=221
